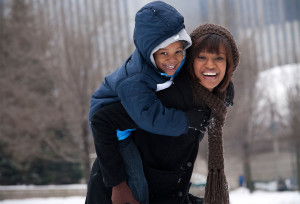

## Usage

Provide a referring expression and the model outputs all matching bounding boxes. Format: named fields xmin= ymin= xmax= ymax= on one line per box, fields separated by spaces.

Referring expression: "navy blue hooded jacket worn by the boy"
xmin=89 ymin=1 xmax=188 ymax=136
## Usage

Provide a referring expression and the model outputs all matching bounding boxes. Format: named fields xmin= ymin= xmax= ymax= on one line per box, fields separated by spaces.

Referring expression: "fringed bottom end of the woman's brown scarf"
xmin=204 ymin=169 xmax=229 ymax=204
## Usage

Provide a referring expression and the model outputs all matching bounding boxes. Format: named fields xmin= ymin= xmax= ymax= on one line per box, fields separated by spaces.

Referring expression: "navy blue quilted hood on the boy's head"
xmin=133 ymin=1 xmax=185 ymax=66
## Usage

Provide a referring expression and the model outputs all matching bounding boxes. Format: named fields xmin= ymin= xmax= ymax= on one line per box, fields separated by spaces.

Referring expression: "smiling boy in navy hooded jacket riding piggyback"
xmin=89 ymin=1 xmax=207 ymax=203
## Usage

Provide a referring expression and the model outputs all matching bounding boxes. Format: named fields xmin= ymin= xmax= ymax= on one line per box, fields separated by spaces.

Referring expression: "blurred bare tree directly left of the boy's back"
xmin=41 ymin=1 xmax=101 ymax=180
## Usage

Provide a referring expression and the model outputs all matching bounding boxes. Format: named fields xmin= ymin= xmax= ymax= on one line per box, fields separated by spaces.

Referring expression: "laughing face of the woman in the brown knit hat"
xmin=193 ymin=44 xmax=226 ymax=91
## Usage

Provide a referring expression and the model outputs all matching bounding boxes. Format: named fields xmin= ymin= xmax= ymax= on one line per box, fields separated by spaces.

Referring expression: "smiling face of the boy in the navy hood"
xmin=153 ymin=41 xmax=183 ymax=76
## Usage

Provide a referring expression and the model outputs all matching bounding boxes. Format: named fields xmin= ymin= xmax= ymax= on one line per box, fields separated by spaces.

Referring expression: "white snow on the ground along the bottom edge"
xmin=0 ymin=188 xmax=300 ymax=204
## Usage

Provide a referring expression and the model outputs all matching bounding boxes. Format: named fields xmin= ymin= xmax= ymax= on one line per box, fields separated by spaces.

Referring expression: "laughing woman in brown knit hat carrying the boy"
xmin=86 ymin=24 xmax=239 ymax=204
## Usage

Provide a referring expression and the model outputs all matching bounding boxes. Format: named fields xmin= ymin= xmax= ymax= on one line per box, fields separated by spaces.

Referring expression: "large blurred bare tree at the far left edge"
xmin=0 ymin=0 xmax=81 ymax=171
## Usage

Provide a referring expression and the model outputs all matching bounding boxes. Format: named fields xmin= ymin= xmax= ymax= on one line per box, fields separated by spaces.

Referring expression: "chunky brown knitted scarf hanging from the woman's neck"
xmin=192 ymin=81 xmax=229 ymax=204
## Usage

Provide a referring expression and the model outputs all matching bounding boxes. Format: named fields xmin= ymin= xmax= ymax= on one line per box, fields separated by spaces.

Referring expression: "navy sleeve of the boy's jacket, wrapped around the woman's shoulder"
xmin=117 ymin=74 xmax=189 ymax=136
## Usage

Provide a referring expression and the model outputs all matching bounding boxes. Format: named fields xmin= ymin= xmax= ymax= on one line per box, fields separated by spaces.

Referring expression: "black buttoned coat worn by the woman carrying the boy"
xmin=87 ymin=70 xmax=209 ymax=203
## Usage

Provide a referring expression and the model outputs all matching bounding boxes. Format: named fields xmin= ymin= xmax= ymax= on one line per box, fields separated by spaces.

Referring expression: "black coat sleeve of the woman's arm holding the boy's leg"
xmin=90 ymin=103 xmax=136 ymax=187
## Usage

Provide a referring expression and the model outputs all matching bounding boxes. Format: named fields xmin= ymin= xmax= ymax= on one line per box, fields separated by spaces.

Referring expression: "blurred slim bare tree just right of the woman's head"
xmin=224 ymin=35 xmax=258 ymax=191
